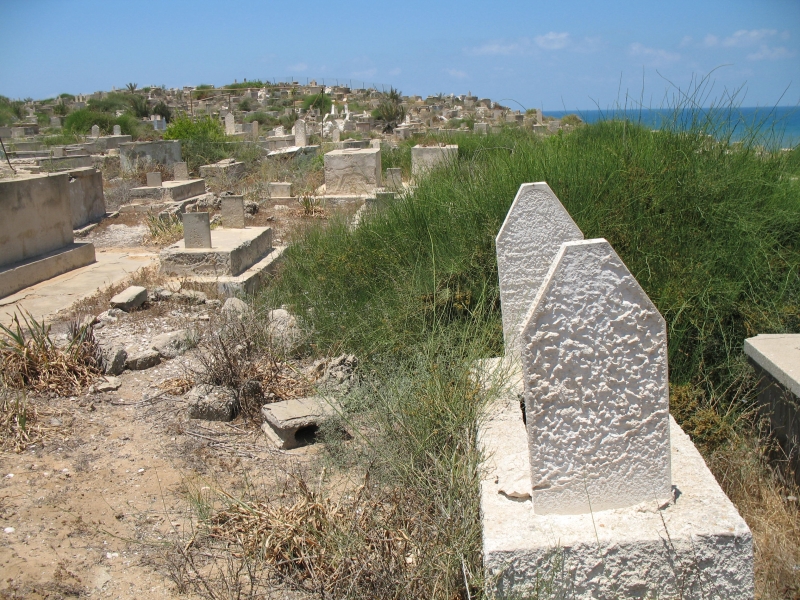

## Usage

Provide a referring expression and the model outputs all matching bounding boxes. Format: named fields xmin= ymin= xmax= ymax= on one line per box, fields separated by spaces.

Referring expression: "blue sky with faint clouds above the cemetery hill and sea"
xmin=0 ymin=0 xmax=800 ymax=110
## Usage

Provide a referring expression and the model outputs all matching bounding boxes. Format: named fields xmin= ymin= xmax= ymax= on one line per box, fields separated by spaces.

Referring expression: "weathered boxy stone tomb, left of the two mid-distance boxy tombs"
xmin=325 ymin=148 xmax=381 ymax=195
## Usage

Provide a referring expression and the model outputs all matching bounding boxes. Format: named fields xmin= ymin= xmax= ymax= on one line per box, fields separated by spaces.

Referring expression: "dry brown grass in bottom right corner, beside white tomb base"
xmin=709 ymin=427 xmax=800 ymax=600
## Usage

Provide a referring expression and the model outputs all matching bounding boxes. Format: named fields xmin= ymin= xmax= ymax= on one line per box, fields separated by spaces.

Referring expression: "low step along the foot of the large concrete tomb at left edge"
xmin=0 ymin=242 xmax=95 ymax=298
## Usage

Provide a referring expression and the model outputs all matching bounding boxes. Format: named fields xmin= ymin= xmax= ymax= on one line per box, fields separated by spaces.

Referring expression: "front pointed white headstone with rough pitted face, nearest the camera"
xmin=521 ymin=239 xmax=672 ymax=515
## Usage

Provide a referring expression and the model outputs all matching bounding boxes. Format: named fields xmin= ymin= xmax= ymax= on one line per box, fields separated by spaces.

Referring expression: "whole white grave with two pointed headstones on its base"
xmin=477 ymin=183 xmax=754 ymax=599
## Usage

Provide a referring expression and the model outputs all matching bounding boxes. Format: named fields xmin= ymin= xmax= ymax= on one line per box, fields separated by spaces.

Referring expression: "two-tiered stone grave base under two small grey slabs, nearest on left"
xmin=160 ymin=227 xmax=284 ymax=295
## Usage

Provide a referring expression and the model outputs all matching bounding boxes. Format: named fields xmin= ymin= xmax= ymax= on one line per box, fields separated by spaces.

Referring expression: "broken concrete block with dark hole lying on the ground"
xmin=261 ymin=396 xmax=336 ymax=450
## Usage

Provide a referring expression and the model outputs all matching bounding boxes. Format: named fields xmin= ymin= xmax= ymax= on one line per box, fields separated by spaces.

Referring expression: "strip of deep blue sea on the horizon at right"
xmin=544 ymin=106 xmax=800 ymax=149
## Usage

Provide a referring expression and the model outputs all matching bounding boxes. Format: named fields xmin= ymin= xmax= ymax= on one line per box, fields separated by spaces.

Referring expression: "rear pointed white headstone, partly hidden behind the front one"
xmin=496 ymin=182 xmax=583 ymax=355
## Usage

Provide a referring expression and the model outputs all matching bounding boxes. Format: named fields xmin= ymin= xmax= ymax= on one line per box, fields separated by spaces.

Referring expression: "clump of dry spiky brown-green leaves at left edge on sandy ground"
xmin=0 ymin=313 xmax=102 ymax=396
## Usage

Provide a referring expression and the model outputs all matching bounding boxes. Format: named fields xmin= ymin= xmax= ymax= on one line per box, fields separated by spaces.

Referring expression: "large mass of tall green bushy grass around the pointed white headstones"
xmin=247 ymin=116 xmax=800 ymax=597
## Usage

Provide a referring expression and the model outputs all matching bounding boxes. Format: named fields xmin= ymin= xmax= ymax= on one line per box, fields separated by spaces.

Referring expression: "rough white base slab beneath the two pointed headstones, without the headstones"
xmin=478 ymin=359 xmax=754 ymax=600
